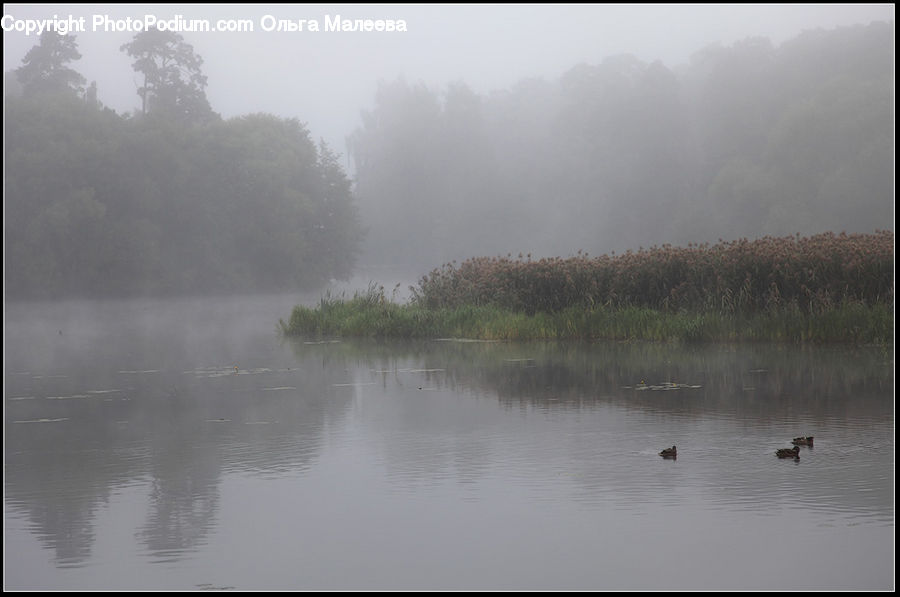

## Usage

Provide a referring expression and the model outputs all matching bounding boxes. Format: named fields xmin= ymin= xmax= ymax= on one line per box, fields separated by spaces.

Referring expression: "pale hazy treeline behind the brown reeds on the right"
xmin=349 ymin=22 xmax=895 ymax=271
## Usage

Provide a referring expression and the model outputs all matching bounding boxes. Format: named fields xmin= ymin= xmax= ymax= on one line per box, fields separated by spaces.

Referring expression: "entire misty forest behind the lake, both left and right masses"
xmin=4 ymin=22 xmax=894 ymax=308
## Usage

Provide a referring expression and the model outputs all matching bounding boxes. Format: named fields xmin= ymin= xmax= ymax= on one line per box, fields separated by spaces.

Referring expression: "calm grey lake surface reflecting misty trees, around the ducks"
xmin=4 ymin=296 xmax=895 ymax=590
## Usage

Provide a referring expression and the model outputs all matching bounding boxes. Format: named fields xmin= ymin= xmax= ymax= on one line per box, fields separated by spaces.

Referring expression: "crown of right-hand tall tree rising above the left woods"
xmin=120 ymin=29 xmax=215 ymax=122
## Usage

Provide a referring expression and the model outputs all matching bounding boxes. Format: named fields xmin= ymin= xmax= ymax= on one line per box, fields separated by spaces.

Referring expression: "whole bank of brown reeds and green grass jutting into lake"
xmin=282 ymin=231 xmax=894 ymax=344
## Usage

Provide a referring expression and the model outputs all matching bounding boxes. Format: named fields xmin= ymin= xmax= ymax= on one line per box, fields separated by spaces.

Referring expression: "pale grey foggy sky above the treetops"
xmin=3 ymin=4 xmax=894 ymax=154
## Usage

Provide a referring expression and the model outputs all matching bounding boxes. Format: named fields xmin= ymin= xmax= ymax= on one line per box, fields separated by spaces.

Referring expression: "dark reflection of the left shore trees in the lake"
xmin=5 ymin=332 xmax=358 ymax=565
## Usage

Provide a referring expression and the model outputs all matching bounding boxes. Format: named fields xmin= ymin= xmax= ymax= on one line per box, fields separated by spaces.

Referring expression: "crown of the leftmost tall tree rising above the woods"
xmin=16 ymin=31 xmax=85 ymax=95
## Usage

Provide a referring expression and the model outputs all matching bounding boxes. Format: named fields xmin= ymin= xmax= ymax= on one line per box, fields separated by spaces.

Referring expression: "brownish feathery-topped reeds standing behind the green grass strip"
xmin=411 ymin=231 xmax=894 ymax=316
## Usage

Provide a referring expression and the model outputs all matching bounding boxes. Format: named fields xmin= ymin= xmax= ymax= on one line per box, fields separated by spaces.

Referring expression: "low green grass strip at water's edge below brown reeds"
xmin=281 ymin=289 xmax=894 ymax=344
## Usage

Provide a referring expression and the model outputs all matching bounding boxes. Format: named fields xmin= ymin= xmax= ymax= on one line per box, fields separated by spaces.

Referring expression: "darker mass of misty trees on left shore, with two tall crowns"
xmin=4 ymin=32 xmax=362 ymax=298
